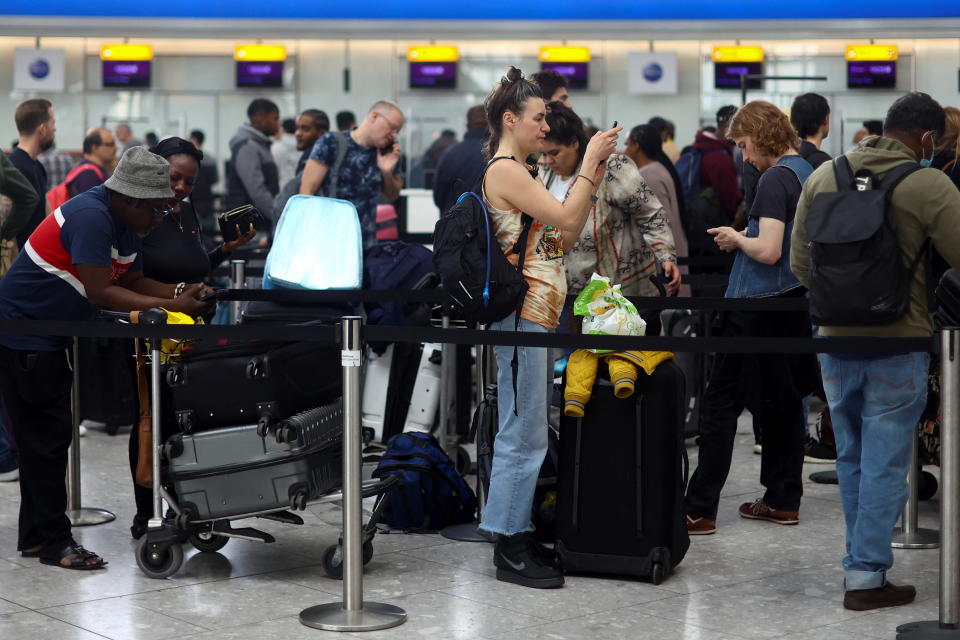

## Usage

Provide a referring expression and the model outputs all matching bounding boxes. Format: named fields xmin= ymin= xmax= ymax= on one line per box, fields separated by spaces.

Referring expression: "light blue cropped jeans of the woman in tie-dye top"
xmin=480 ymin=315 xmax=549 ymax=536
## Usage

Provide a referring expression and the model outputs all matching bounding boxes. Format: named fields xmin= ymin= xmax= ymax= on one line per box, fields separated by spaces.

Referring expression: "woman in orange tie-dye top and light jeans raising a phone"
xmin=480 ymin=67 xmax=622 ymax=588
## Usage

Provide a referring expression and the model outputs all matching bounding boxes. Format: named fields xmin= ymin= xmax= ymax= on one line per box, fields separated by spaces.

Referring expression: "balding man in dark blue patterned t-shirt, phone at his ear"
xmin=300 ymin=100 xmax=404 ymax=247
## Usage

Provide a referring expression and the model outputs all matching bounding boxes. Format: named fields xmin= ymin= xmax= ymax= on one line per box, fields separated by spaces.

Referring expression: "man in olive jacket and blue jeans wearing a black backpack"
xmin=790 ymin=92 xmax=960 ymax=611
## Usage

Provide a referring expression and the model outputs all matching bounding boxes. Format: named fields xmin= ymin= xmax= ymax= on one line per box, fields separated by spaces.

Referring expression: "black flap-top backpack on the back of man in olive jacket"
xmin=806 ymin=155 xmax=929 ymax=327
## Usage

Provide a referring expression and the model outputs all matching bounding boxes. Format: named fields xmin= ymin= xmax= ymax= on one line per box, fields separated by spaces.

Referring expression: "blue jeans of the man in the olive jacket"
xmin=820 ymin=353 xmax=930 ymax=590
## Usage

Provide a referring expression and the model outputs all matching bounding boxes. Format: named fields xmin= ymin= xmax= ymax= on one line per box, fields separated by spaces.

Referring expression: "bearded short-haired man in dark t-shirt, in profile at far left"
xmin=10 ymin=98 xmax=57 ymax=248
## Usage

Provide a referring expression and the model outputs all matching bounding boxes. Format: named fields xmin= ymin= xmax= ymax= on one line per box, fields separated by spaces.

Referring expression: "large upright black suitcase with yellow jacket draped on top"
xmin=557 ymin=361 xmax=690 ymax=584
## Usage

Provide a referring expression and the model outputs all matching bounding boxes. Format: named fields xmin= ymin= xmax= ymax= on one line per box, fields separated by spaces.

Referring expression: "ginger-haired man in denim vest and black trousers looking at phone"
xmin=686 ymin=100 xmax=816 ymax=535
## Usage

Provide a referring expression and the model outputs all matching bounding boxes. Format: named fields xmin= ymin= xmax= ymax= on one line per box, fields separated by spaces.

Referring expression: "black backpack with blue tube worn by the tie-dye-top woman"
xmin=433 ymin=156 xmax=533 ymax=324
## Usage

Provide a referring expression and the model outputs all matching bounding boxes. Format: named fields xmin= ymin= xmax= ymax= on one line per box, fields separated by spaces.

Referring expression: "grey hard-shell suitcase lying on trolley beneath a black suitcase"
xmin=163 ymin=401 xmax=343 ymax=522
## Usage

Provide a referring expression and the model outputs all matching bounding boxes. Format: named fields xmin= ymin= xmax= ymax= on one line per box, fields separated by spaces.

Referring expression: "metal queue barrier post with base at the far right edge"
xmin=897 ymin=328 xmax=960 ymax=640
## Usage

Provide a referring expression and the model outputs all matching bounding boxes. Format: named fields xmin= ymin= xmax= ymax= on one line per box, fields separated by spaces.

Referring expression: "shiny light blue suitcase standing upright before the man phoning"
xmin=263 ymin=195 xmax=363 ymax=289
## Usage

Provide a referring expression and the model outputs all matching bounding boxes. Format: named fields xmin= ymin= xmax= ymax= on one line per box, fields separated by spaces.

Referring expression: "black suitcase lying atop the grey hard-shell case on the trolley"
xmin=164 ymin=341 xmax=342 ymax=432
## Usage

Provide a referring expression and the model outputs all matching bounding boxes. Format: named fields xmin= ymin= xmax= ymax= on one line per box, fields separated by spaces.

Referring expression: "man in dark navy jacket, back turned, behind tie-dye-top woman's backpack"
xmin=433 ymin=105 xmax=490 ymax=211
